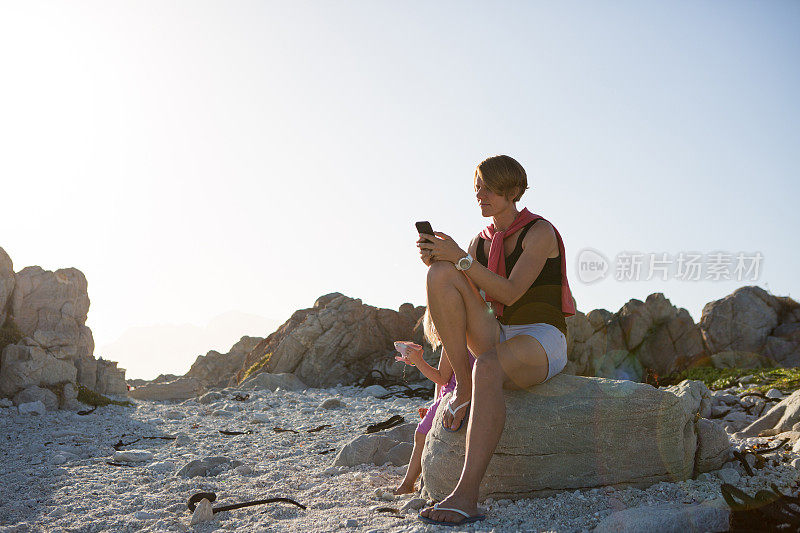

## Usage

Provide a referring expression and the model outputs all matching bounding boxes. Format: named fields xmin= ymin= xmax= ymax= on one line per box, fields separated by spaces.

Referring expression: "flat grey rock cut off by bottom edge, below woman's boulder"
xmin=593 ymin=499 xmax=730 ymax=533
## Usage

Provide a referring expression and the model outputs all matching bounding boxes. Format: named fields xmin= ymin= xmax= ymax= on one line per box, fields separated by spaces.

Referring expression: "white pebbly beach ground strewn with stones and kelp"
xmin=0 ymin=387 xmax=800 ymax=532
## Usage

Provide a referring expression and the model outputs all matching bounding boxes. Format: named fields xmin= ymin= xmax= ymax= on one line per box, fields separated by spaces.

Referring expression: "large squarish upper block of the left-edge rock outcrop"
xmin=12 ymin=266 xmax=94 ymax=360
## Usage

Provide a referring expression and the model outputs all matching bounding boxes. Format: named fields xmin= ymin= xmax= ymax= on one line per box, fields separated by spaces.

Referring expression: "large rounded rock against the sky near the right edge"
xmin=700 ymin=285 xmax=782 ymax=353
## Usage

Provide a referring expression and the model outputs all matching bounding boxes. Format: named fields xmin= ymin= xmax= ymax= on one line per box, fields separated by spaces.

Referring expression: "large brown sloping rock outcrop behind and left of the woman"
xmin=237 ymin=293 xmax=424 ymax=387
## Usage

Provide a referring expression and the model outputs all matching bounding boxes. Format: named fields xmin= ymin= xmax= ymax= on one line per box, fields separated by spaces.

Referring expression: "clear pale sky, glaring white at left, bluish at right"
xmin=0 ymin=0 xmax=800 ymax=377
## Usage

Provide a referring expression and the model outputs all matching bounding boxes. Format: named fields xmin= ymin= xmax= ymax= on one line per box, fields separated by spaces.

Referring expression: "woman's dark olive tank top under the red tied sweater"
xmin=475 ymin=219 xmax=567 ymax=336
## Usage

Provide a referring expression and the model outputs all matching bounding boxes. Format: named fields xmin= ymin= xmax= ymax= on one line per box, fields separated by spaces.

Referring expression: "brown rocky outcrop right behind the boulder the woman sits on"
xmin=566 ymin=293 xmax=705 ymax=381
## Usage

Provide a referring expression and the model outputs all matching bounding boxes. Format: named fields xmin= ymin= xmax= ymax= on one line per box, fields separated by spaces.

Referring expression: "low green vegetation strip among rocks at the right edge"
xmin=659 ymin=367 xmax=800 ymax=392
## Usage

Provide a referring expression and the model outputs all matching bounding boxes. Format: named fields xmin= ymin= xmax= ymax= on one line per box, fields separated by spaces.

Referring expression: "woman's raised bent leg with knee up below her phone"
xmin=427 ymin=261 xmax=498 ymax=429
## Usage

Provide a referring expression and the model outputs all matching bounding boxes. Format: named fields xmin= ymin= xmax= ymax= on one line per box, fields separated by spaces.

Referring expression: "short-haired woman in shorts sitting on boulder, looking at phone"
xmin=417 ymin=155 xmax=575 ymax=525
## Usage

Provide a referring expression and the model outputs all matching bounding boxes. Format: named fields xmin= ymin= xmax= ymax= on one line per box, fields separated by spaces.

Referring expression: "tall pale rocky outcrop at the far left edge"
xmin=0 ymin=248 xmax=127 ymax=406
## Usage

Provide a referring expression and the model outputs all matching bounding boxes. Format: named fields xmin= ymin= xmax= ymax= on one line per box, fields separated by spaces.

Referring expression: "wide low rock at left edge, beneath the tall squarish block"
xmin=0 ymin=339 xmax=77 ymax=397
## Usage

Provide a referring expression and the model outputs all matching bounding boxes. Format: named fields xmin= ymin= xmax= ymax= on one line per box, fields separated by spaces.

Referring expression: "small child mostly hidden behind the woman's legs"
xmin=394 ymin=309 xmax=475 ymax=494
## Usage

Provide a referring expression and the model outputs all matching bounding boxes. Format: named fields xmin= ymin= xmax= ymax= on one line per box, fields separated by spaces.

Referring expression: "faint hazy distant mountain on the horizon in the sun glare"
xmin=95 ymin=311 xmax=282 ymax=379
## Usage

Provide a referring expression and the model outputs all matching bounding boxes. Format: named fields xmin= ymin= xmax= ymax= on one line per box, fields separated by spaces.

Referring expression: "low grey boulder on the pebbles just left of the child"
xmin=333 ymin=423 xmax=417 ymax=466
